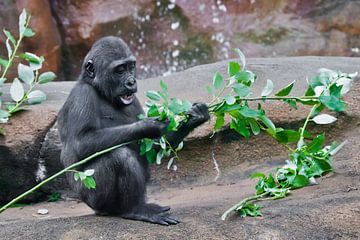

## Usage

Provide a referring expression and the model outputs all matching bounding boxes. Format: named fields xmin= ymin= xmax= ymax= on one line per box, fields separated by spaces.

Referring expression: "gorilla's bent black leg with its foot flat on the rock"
xmin=77 ymin=147 xmax=178 ymax=225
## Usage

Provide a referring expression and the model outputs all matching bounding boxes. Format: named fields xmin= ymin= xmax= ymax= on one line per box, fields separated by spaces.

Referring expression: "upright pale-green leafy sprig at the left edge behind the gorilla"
xmin=0 ymin=9 xmax=56 ymax=135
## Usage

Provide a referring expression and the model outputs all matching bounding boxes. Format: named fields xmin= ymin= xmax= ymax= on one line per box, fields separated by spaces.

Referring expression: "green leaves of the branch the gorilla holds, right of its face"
xmin=141 ymin=49 xmax=357 ymax=220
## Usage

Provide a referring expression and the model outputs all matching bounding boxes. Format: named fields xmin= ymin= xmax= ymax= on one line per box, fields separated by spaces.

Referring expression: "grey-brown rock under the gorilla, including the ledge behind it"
xmin=0 ymin=57 xmax=360 ymax=239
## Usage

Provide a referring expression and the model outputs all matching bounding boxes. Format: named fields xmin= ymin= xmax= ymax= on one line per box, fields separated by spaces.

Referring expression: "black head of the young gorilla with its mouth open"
xmin=81 ymin=37 xmax=137 ymax=105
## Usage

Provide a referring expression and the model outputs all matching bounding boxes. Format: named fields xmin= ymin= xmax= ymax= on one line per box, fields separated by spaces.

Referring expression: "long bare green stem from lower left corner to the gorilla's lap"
xmin=0 ymin=142 xmax=131 ymax=213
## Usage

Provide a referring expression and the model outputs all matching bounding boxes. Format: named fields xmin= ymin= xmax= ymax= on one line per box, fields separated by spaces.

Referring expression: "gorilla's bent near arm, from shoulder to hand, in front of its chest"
xmin=59 ymin=84 xmax=166 ymax=158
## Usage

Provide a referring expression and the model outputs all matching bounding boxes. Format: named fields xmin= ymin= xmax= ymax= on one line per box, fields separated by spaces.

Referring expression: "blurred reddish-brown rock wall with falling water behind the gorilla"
xmin=0 ymin=0 xmax=360 ymax=81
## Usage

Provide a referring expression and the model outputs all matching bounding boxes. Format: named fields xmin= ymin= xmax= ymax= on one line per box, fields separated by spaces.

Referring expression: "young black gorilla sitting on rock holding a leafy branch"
xmin=58 ymin=37 xmax=209 ymax=225
